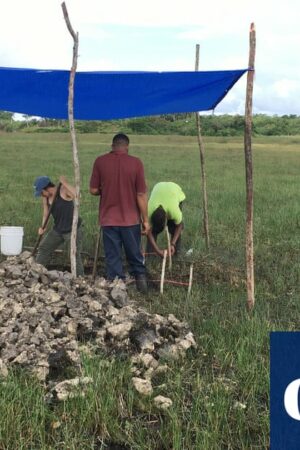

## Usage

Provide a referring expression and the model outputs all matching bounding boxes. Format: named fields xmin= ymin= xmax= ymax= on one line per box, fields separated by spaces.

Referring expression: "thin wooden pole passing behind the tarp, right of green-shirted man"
xmin=195 ymin=44 xmax=209 ymax=250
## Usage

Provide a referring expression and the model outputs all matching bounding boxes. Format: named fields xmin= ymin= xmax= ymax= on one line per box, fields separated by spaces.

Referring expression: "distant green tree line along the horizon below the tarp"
xmin=0 ymin=111 xmax=300 ymax=136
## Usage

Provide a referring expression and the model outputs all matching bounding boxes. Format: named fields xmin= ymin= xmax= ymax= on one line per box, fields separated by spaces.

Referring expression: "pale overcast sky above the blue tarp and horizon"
xmin=0 ymin=0 xmax=300 ymax=115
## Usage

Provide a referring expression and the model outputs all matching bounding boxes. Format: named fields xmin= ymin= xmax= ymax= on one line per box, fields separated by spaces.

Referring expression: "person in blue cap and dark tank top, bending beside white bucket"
xmin=33 ymin=176 xmax=84 ymax=276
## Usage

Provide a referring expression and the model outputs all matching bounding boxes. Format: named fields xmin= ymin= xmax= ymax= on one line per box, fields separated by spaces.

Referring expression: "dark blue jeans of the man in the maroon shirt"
xmin=102 ymin=224 xmax=145 ymax=280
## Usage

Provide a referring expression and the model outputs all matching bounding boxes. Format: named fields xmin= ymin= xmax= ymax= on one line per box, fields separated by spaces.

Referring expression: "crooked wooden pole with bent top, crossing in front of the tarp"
xmin=61 ymin=2 xmax=80 ymax=277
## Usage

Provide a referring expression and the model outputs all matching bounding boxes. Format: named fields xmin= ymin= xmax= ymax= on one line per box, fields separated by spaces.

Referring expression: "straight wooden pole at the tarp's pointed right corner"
xmin=244 ymin=23 xmax=256 ymax=310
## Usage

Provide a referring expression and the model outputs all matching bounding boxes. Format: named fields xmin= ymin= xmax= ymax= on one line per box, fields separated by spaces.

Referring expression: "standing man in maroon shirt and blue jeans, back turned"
xmin=90 ymin=133 xmax=150 ymax=293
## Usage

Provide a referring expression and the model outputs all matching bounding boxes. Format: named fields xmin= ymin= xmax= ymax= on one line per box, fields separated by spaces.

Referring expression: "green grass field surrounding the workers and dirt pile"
xmin=0 ymin=133 xmax=300 ymax=450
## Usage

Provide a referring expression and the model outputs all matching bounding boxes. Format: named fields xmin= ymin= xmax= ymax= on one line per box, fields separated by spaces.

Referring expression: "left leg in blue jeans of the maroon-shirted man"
xmin=102 ymin=227 xmax=125 ymax=280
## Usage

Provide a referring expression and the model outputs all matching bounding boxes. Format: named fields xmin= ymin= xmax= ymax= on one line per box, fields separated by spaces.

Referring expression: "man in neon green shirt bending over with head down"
xmin=146 ymin=181 xmax=185 ymax=257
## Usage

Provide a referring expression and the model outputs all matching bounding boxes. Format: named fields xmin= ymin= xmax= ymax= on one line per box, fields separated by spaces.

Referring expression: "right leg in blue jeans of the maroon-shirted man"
xmin=120 ymin=224 xmax=147 ymax=293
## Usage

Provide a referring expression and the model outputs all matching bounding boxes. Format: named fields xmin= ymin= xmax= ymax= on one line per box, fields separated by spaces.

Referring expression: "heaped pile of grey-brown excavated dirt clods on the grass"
xmin=0 ymin=252 xmax=196 ymax=398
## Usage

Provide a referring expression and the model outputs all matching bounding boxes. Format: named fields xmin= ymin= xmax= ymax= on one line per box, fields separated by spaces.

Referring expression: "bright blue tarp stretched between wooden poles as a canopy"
xmin=0 ymin=67 xmax=248 ymax=120
